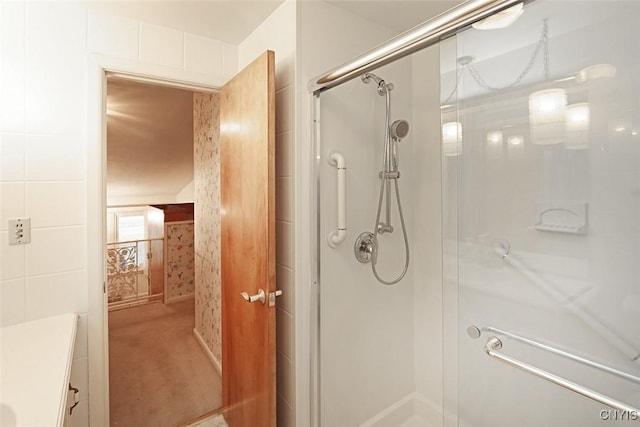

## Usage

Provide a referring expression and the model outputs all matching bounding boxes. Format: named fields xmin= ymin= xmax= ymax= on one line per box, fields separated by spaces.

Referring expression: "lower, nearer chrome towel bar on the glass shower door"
xmin=484 ymin=337 xmax=640 ymax=414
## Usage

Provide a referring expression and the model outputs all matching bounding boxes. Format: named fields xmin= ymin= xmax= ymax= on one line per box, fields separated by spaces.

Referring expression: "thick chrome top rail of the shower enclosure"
xmin=308 ymin=0 xmax=523 ymax=93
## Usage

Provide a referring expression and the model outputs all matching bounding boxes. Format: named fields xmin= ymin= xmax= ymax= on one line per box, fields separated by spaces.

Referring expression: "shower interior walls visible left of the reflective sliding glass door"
xmin=316 ymin=47 xmax=442 ymax=427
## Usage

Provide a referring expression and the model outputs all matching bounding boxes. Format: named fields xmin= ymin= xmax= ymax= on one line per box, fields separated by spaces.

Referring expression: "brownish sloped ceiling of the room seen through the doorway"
xmin=107 ymin=79 xmax=193 ymax=205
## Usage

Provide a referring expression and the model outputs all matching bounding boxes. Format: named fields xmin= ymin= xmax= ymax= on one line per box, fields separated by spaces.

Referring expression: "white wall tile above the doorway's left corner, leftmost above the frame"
xmin=87 ymin=11 xmax=140 ymax=60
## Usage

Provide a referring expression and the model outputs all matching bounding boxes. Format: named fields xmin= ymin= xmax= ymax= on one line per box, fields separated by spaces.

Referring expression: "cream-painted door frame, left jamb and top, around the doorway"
xmin=85 ymin=54 xmax=224 ymax=426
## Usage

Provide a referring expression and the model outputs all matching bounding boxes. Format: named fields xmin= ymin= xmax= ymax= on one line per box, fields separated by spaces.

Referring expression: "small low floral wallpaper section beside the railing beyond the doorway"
xmin=165 ymin=221 xmax=195 ymax=302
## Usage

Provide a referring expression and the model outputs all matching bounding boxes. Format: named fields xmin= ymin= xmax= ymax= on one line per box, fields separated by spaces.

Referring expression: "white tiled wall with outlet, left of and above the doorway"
xmin=0 ymin=2 xmax=237 ymax=426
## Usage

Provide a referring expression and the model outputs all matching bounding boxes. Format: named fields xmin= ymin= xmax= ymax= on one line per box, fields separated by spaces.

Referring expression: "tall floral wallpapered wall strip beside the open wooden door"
xmin=193 ymin=93 xmax=222 ymax=364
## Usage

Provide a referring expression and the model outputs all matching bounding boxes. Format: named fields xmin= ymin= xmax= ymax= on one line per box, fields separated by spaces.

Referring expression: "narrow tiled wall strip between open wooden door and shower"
xmin=238 ymin=0 xmax=298 ymax=427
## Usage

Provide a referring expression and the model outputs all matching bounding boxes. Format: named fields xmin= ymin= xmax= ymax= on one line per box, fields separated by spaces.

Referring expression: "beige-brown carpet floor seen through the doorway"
xmin=109 ymin=300 xmax=222 ymax=427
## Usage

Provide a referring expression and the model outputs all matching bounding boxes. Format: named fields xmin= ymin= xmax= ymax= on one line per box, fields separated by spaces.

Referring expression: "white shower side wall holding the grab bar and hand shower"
xmin=319 ymin=57 xmax=413 ymax=426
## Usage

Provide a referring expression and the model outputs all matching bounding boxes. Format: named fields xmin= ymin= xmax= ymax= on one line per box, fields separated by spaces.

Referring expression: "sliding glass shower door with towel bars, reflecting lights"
xmin=448 ymin=0 xmax=640 ymax=427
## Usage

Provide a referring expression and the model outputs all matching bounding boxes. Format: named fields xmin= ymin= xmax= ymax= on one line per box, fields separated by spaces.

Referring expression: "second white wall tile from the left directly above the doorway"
xmin=140 ymin=22 xmax=184 ymax=68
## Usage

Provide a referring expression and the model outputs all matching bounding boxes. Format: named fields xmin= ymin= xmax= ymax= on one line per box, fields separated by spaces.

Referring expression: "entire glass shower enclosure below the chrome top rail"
xmin=314 ymin=0 xmax=640 ymax=427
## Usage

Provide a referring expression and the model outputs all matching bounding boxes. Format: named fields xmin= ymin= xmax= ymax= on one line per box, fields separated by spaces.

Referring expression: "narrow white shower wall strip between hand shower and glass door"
xmin=409 ymin=46 xmax=443 ymax=426
